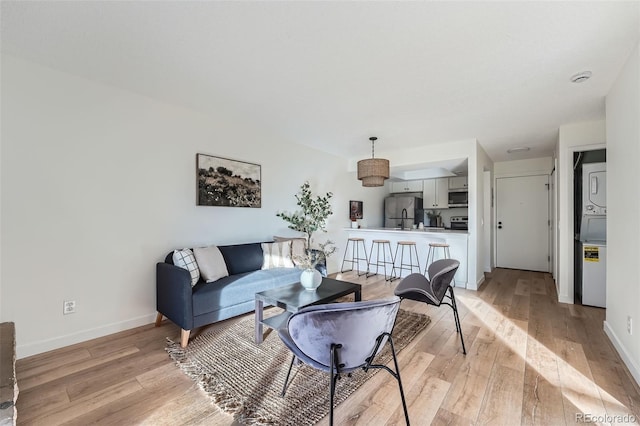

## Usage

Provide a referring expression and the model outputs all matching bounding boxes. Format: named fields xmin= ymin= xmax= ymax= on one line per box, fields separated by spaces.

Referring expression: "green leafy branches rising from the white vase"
xmin=276 ymin=181 xmax=333 ymax=248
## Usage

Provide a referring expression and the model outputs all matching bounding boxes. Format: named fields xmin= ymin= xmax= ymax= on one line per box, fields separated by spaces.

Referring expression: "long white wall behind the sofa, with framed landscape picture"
xmin=0 ymin=55 xmax=386 ymax=357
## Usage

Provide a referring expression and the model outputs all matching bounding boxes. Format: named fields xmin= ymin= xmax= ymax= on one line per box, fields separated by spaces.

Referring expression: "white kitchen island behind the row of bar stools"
xmin=345 ymin=227 xmax=469 ymax=288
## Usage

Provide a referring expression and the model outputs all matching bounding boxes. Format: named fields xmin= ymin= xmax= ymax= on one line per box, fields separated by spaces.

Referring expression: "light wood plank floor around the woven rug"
xmin=17 ymin=269 xmax=640 ymax=425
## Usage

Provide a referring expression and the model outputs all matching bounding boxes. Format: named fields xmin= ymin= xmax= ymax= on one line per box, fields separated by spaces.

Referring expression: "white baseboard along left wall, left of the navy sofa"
xmin=16 ymin=312 xmax=157 ymax=359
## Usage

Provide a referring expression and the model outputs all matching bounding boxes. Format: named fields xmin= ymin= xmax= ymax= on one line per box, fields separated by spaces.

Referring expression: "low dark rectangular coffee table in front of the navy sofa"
xmin=256 ymin=278 xmax=362 ymax=343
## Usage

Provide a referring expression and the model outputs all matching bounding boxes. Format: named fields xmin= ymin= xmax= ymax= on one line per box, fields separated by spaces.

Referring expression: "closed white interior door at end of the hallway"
xmin=496 ymin=175 xmax=549 ymax=272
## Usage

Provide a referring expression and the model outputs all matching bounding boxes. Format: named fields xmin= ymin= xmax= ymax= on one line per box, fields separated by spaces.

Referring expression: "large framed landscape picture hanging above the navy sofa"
xmin=196 ymin=154 xmax=262 ymax=208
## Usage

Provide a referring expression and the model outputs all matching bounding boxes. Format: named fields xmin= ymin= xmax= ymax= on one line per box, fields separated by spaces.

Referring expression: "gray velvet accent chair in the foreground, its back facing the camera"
xmin=278 ymin=297 xmax=409 ymax=425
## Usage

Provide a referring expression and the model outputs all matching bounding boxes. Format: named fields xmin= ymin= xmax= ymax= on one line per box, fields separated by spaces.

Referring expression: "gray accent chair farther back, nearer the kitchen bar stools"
xmin=394 ymin=259 xmax=467 ymax=355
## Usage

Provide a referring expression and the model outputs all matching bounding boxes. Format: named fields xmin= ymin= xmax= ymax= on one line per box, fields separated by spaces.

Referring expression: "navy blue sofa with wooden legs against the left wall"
xmin=156 ymin=243 xmax=326 ymax=347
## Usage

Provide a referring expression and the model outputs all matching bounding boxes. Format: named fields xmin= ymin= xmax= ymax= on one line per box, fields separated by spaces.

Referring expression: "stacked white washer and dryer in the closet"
xmin=579 ymin=163 xmax=607 ymax=308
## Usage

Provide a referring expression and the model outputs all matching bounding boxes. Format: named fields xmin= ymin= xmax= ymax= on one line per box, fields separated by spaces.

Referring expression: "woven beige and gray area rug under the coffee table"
xmin=166 ymin=309 xmax=430 ymax=426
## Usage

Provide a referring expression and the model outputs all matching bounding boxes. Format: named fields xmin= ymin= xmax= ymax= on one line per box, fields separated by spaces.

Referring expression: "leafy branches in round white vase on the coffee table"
xmin=276 ymin=181 xmax=336 ymax=290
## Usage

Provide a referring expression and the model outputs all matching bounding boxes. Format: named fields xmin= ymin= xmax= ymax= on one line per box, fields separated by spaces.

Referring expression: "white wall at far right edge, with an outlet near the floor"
xmin=605 ymin=41 xmax=640 ymax=383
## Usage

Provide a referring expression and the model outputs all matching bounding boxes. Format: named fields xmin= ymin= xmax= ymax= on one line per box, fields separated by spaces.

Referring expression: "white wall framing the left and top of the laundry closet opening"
xmin=556 ymin=120 xmax=611 ymax=303
